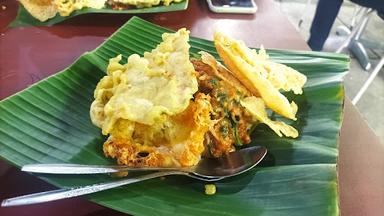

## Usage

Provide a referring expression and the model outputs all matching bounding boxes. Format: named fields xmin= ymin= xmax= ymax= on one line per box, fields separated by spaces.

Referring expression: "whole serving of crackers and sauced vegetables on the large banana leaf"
xmin=91 ymin=30 xmax=306 ymax=167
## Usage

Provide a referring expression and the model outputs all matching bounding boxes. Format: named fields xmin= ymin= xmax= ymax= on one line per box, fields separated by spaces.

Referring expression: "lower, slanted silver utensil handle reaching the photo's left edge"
xmin=1 ymin=171 xmax=180 ymax=207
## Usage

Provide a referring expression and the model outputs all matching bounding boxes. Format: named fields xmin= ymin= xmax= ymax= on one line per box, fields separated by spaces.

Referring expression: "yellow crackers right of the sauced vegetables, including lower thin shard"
xmin=214 ymin=32 xmax=307 ymax=138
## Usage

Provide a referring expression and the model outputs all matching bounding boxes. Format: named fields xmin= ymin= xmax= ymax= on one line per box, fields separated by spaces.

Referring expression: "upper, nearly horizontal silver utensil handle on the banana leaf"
xmin=21 ymin=164 xmax=181 ymax=174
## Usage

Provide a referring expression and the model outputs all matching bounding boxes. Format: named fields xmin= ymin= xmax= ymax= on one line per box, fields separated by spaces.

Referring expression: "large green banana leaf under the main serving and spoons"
xmin=0 ymin=17 xmax=349 ymax=216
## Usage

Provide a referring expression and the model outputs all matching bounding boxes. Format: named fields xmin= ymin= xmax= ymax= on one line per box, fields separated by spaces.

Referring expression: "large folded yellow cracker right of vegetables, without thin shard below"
xmin=214 ymin=32 xmax=307 ymax=120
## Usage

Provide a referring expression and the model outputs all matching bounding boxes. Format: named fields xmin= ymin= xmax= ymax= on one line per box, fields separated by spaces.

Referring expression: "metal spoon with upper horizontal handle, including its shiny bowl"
xmin=21 ymin=146 xmax=267 ymax=178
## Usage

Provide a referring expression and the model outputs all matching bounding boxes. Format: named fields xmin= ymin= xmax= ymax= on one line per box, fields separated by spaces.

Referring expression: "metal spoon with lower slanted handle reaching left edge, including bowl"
xmin=1 ymin=146 xmax=267 ymax=207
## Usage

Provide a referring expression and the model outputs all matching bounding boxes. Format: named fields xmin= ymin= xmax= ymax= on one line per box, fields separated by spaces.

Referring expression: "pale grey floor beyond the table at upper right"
xmin=275 ymin=0 xmax=384 ymax=143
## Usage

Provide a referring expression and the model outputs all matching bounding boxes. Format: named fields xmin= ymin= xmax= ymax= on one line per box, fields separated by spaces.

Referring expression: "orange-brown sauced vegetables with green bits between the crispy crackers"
xmin=192 ymin=52 xmax=255 ymax=157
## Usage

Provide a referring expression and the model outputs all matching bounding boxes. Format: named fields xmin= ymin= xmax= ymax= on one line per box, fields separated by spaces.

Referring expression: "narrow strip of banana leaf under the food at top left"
xmin=9 ymin=0 xmax=188 ymax=27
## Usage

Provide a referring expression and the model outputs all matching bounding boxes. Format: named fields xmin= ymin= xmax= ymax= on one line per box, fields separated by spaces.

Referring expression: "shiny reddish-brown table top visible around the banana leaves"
xmin=0 ymin=0 xmax=384 ymax=216
